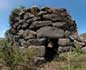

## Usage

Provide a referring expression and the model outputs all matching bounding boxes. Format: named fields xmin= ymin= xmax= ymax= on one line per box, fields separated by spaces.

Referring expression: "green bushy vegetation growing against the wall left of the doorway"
xmin=0 ymin=41 xmax=36 ymax=70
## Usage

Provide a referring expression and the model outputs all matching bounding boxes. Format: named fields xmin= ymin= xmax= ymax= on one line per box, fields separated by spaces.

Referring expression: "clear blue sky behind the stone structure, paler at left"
xmin=0 ymin=0 xmax=86 ymax=37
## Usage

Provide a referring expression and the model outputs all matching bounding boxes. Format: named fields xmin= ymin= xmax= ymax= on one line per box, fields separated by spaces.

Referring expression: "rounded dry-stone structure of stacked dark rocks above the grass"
xmin=8 ymin=6 xmax=86 ymax=61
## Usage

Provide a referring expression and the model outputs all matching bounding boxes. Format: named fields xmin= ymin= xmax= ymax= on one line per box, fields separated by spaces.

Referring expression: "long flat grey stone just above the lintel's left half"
xmin=29 ymin=21 xmax=52 ymax=29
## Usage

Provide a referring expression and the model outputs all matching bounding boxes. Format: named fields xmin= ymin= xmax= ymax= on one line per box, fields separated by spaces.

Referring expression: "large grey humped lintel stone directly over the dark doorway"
xmin=37 ymin=26 xmax=64 ymax=38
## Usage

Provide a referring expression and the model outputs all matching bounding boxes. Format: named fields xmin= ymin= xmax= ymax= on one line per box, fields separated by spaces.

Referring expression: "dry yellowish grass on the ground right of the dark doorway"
xmin=38 ymin=52 xmax=86 ymax=70
